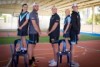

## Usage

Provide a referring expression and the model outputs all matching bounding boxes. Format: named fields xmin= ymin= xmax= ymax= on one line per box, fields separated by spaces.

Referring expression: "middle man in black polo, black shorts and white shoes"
xmin=48 ymin=6 xmax=60 ymax=66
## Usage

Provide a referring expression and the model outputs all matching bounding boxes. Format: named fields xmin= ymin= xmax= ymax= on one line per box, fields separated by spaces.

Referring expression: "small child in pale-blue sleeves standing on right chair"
xmin=63 ymin=9 xmax=71 ymax=51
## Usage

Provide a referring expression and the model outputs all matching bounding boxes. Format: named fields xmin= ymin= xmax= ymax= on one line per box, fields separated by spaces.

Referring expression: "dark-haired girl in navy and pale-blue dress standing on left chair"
xmin=18 ymin=4 xmax=29 ymax=53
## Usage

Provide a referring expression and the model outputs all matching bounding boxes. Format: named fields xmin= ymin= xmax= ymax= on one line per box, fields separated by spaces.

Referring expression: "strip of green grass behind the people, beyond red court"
xmin=0 ymin=35 xmax=100 ymax=44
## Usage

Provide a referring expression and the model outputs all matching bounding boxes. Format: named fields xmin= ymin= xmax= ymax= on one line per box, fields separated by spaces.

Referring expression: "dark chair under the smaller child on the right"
xmin=53 ymin=39 xmax=72 ymax=67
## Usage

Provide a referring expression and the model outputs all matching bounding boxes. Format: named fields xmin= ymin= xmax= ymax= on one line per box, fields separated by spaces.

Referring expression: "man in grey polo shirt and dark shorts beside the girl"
xmin=28 ymin=3 xmax=41 ymax=66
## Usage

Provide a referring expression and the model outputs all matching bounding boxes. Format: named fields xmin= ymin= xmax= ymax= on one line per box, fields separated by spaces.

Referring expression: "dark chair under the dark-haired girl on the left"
xmin=10 ymin=39 xmax=28 ymax=67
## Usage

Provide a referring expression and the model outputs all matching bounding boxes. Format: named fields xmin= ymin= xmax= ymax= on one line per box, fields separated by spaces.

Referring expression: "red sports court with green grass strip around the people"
xmin=0 ymin=32 xmax=100 ymax=67
